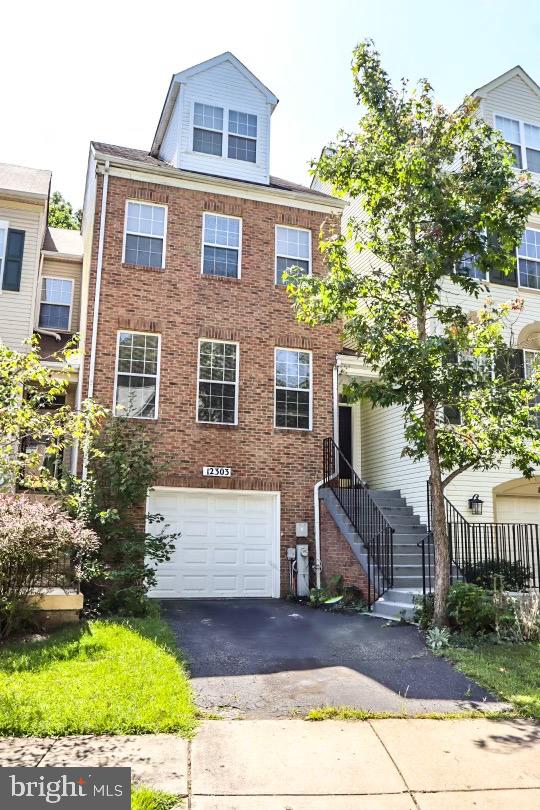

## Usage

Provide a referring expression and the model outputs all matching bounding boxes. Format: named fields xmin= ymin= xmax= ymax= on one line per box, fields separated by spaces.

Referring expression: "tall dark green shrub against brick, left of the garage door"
xmin=73 ymin=417 xmax=179 ymax=616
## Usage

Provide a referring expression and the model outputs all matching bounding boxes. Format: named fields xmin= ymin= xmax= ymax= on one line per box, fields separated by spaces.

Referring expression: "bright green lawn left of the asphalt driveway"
xmin=0 ymin=618 xmax=196 ymax=736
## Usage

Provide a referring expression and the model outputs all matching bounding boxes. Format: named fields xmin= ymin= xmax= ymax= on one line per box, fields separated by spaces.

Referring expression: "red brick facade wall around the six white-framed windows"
xmin=81 ymin=176 xmax=340 ymax=593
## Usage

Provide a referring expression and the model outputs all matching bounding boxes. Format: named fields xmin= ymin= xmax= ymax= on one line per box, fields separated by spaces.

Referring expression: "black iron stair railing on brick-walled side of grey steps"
xmin=323 ymin=438 xmax=394 ymax=608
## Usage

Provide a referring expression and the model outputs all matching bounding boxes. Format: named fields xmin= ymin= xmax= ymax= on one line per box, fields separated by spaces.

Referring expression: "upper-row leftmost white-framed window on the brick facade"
xmin=123 ymin=200 xmax=167 ymax=268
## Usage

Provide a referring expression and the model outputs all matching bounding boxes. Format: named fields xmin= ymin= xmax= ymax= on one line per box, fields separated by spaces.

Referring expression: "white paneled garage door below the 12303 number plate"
xmin=148 ymin=488 xmax=279 ymax=599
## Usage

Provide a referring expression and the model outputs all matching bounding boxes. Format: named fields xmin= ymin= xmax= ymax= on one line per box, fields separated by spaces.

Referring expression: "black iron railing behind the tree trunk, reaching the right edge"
xmin=418 ymin=482 xmax=540 ymax=593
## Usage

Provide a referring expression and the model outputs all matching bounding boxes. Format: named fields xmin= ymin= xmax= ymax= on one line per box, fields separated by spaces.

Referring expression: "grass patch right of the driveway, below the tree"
xmin=443 ymin=642 xmax=540 ymax=720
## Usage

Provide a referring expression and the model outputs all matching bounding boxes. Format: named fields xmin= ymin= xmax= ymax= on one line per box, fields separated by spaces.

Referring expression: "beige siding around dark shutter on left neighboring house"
xmin=0 ymin=200 xmax=44 ymax=351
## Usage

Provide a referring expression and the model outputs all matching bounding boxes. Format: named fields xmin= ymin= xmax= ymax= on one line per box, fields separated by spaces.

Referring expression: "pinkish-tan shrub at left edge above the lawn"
xmin=0 ymin=495 xmax=99 ymax=638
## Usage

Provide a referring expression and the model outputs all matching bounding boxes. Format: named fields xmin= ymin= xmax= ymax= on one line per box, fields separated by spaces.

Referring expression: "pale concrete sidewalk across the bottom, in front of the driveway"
xmin=0 ymin=719 xmax=540 ymax=810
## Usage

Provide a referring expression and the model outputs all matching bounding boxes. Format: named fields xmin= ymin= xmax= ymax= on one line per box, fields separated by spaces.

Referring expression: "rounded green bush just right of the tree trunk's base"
xmin=447 ymin=582 xmax=498 ymax=636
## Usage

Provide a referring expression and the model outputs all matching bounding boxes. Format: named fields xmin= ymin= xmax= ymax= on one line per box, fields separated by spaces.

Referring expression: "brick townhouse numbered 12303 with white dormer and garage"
xmin=78 ymin=53 xmax=343 ymax=597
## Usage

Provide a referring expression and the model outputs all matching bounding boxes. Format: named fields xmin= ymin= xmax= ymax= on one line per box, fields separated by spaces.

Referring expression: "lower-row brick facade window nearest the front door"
xmin=275 ymin=349 xmax=312 ymax=430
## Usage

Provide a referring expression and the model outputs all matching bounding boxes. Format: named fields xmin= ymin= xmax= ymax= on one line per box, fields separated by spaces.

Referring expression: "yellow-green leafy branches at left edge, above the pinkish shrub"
xmin=0 ymin=338 xmax=106 ymax=492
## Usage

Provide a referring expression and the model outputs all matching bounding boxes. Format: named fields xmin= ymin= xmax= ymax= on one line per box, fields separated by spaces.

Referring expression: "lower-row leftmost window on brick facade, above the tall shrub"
xmin=114 ymin=331 xmax=160 ymax=419
